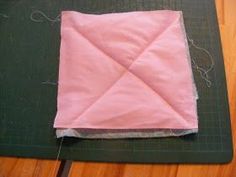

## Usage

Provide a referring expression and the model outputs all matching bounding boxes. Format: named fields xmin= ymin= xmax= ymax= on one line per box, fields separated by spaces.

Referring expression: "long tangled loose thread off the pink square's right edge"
xmin=187 ymin=35 xmax=215 ymax=87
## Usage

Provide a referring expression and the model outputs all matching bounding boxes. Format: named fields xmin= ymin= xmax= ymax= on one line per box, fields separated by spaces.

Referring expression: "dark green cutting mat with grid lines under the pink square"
xmin=0 ymin=0 xmax=232 ymax=163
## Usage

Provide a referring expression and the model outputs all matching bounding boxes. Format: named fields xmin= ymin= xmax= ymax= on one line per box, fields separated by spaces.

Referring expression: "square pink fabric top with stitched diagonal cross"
xmin=54 ymin=10 xmax=198 ymax=129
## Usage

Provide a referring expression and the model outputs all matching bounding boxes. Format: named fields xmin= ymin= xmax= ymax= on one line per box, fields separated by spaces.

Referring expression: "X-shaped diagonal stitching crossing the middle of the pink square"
xmin=71 ymin=15 xmax=183 ymax=118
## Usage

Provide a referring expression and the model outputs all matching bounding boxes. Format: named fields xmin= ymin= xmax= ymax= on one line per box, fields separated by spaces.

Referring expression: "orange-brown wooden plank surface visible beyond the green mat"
xmin=0 ymin=0 xmax=236 ymax=177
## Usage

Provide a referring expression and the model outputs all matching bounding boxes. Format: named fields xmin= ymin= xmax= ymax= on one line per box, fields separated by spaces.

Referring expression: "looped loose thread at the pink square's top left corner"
xmin=30 ymin=10 xmax=61 ymax=23
